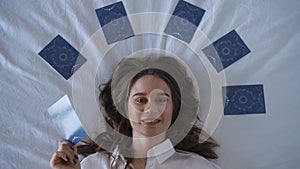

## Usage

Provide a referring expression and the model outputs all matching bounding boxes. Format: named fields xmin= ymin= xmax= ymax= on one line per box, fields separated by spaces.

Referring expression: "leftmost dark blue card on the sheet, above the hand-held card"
xmin=39 ymin=35 xmax=86 ymax=79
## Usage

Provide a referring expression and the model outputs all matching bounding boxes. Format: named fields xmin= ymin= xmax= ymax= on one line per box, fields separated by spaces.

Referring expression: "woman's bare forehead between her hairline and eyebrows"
xmin=130 ymin=75 xmax=171 ymax=93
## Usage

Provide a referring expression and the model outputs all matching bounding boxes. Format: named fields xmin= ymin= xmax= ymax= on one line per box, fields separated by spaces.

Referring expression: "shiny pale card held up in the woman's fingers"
xmin=48 ymin=95 xmax=88 ymax=144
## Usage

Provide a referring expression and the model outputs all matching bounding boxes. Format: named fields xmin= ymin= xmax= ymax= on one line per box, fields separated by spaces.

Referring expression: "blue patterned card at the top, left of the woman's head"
xmin=96 ymin=2 xmax=134 ymax=44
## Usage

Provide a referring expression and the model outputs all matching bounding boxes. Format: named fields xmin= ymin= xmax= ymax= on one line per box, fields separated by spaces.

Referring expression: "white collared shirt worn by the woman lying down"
xmin=81 ymin=139 xmax=220 ymax=169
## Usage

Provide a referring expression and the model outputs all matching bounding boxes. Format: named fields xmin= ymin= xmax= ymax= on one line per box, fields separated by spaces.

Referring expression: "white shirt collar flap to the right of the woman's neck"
xmin=147 ymin=139 xmax=175 ymax=164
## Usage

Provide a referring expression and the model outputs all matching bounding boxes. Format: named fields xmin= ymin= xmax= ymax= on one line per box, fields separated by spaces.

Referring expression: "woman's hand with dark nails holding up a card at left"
xmin=50 ymin=141 xmax=80 ymax=169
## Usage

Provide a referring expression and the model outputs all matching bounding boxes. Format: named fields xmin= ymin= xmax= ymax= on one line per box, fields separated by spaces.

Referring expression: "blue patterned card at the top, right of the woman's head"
xmin=164 ymin=0 xmax=205 ymax=43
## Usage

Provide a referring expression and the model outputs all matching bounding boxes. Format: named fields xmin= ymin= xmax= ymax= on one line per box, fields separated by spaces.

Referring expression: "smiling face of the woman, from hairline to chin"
xmin=128 ymin=75 xmax=173 ymax=138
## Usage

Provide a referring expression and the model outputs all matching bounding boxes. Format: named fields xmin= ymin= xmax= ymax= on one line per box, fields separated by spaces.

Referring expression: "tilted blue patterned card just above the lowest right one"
xmin=202 ymin=30 xmax=251 ymax=72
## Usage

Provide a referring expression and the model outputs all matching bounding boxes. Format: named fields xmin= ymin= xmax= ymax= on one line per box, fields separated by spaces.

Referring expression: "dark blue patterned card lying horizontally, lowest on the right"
xmin=223 ymin=85 xmax=266 ymax=115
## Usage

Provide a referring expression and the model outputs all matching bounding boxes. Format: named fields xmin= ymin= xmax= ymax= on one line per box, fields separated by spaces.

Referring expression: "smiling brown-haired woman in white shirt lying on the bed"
xmin=50 ymin=55 xmax=218 ymax=169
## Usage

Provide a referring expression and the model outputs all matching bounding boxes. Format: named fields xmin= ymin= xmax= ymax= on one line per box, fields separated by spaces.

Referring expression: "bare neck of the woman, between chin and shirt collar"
xmin=132 ymin=133 xmax=166 ymax=159
